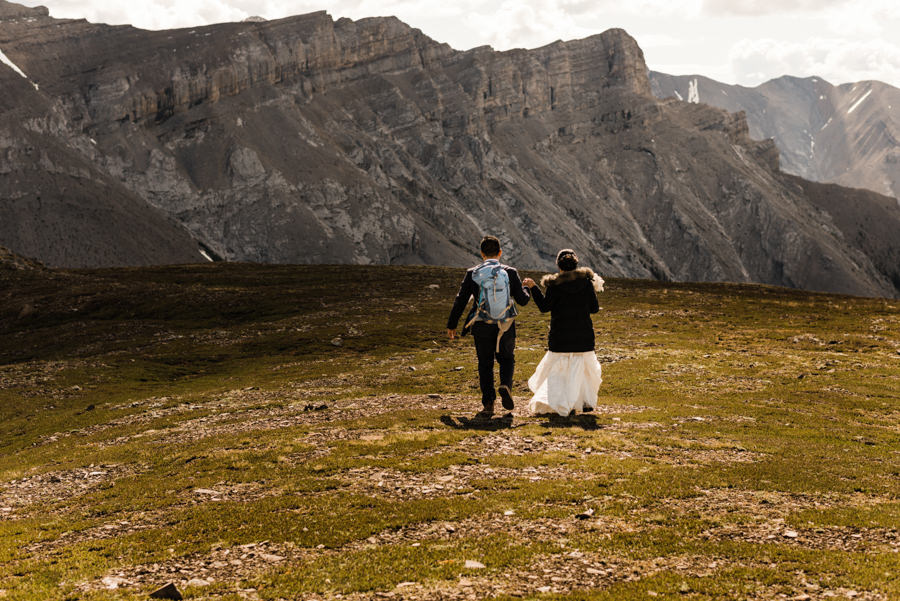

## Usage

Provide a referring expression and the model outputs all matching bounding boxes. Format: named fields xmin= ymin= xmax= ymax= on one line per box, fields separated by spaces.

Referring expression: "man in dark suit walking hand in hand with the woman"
xmin=447 ymin=236 xmax=531 ymax=414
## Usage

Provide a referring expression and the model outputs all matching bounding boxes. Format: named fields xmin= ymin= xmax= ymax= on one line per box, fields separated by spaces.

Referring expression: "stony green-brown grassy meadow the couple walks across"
xmin=0 ymin=264 xmax=900 ymax=601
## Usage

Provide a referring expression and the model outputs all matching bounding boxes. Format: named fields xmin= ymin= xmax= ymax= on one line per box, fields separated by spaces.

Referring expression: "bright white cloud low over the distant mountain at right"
xmin=729 ymin=38 xmax=900 ymax=85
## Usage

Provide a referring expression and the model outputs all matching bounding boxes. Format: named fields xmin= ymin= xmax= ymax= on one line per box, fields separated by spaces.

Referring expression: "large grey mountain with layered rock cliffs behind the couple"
xmin=0 ymin=0 xmax=900 ymax=296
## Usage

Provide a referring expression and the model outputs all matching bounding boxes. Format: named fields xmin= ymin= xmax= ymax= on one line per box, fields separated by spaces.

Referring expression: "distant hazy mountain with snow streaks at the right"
xmin=650 ymin=72 xmax=900 ymax=198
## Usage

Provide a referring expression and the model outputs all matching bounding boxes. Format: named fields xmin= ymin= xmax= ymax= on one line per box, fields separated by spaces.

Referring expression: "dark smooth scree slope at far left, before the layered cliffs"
xmin=0 ymin=36 xmax=204 ymax=267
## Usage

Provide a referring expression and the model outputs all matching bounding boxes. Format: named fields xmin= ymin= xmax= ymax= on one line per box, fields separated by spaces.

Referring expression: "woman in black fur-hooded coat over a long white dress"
xmin=522 ymin=248 xmax=603 ymax=415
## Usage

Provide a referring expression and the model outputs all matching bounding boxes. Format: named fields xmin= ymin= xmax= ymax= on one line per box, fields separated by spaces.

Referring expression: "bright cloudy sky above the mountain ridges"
xmin=13 ymin=0 xmax=900 ymax=87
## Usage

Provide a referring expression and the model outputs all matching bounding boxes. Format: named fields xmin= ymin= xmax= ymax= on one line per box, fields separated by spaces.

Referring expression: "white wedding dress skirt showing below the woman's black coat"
xmin=528 ymin=351 xmax=603 ymax=415
